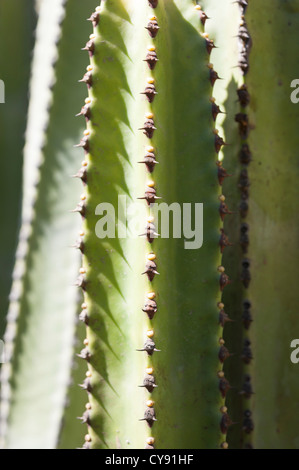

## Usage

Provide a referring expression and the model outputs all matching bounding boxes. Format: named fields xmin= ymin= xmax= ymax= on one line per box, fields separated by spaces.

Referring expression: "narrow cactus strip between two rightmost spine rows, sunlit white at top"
xmin=199 ymin=0 xmax=243 ymax=448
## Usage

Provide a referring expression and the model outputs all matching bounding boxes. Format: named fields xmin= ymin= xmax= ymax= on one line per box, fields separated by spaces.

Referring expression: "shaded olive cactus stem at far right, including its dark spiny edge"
xmin=223 ymin=0 xmax=299 ymax=449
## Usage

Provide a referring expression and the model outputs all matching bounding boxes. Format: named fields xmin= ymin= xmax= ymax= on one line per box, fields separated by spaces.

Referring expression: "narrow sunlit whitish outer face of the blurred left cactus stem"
xmin=0 ymin=0 xmax=65 ymax=447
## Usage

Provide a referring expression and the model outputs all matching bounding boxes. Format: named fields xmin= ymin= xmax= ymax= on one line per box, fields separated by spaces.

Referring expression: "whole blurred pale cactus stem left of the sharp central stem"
xmin=1 ymin=0 xmax=101 ymax=448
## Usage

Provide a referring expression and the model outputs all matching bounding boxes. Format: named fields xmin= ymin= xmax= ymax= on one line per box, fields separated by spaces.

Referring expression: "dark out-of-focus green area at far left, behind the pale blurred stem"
xmin=0 ymin=0 xmax=35 ymax=339
